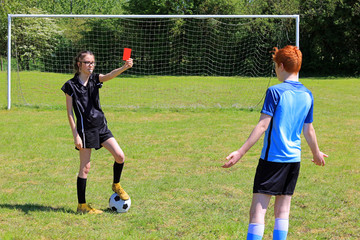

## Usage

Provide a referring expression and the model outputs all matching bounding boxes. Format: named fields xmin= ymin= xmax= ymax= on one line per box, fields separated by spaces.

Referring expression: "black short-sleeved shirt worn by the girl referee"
xmin=61 ymin=73 xmax=106 ymax=131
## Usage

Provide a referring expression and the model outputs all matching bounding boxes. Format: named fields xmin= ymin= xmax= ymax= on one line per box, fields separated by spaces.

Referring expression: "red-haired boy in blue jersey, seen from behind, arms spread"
xmin=223 ymin=46 xmax=328 ymax=240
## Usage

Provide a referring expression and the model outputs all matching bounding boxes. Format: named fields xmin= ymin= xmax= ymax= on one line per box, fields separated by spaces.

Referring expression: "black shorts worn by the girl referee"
xmin=75 ymin=124 xmax=114 ymax=150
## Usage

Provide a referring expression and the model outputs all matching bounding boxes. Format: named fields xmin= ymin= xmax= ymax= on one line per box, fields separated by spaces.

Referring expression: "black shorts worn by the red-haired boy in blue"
xmin=253 ymin=159 xmax=300 ymax=195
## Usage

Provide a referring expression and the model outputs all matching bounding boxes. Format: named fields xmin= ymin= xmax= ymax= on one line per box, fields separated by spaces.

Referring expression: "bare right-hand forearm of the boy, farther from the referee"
xmin=303 ymin=123 xmax=328 ymax=166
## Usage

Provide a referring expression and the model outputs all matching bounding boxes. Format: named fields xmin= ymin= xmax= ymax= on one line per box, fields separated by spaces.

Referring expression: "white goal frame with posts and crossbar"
xmin=7 ymin=14 xmax=300 ymax=109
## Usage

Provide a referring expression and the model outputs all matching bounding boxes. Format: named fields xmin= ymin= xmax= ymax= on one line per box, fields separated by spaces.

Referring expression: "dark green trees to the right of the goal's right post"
xmin=301 ymin=0 xmax=360 ymax=75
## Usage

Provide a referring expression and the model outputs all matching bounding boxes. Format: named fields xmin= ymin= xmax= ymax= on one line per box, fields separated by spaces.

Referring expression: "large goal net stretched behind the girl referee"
xmin=9 ymin=15 xmax=298 ymax=111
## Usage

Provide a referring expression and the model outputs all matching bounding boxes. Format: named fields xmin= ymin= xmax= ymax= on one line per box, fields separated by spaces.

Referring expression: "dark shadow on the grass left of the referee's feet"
xmin=0 ymin=203 xmax=76 ymax=214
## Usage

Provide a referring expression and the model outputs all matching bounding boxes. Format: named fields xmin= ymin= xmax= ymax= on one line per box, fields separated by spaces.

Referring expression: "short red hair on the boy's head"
xmin=272 ymin=45 xmax=302 ymax=73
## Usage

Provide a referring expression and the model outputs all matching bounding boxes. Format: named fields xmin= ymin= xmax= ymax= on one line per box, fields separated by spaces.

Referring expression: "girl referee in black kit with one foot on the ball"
xmin=61 ymin=51 xmax=133 ymax=214
